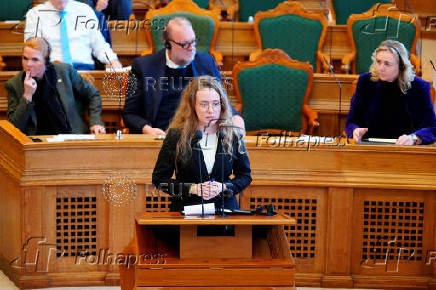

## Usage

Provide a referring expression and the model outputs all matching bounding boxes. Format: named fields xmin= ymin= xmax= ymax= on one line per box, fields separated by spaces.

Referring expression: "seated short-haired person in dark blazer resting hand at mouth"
xmin=5 ymin=37 xmax=105 ymax=135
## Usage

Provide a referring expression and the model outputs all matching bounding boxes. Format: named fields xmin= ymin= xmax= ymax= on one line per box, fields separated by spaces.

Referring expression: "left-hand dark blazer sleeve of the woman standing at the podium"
xmin=152 ymin=129 xmax=190 ymax=197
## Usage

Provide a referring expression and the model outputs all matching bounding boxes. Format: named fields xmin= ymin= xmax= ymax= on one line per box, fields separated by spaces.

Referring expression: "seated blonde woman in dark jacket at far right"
xmin=345 ymin=40 xmax=436 ymax=145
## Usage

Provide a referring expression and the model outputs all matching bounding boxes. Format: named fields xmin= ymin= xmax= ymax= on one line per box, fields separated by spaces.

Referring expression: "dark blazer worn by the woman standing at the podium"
xmin=152 ymin=129 xmax=251 ymax=211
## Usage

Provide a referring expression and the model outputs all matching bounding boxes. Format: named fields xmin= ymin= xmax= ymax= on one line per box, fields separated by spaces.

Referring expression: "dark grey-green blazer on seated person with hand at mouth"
xmin=5 ymin=63 xmax=103 ymax=135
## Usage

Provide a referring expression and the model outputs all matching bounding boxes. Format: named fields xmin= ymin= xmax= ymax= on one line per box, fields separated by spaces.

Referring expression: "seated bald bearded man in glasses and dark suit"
xmin=123 ymin=17 xmax=244 ymax=135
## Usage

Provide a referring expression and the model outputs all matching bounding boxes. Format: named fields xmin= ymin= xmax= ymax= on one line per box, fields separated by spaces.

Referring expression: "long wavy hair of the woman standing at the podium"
xmin=168 ymin=76 xmax=238 ymax=162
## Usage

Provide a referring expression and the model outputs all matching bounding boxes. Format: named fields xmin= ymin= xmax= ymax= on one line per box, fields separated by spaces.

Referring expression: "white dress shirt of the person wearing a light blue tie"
xmin=24 ymin=0 xmax=117 ymax=64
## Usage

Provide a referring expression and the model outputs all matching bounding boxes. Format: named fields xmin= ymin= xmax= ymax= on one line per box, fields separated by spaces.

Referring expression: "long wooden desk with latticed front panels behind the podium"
xmin=0 ymin=121 xmax=436 ymax=289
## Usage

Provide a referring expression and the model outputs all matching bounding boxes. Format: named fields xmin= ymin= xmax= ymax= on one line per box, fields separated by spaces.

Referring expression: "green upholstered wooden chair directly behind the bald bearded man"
xmin=142 ymin=0 xmax=223 ymax=64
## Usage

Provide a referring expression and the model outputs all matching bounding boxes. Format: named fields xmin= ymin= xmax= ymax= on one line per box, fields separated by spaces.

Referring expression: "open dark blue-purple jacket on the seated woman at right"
xmin=345 ymin=73 xmax=436 ymax=144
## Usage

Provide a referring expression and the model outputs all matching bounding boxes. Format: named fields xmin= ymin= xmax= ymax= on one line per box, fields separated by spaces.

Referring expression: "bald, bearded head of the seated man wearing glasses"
xmin=168 ymin=25 xmax=196 ymax=65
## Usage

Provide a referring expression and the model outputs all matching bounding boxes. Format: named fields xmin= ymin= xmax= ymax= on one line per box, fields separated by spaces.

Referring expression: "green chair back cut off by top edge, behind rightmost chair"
xmin=330 ymin=0 xmax=391 ymax=25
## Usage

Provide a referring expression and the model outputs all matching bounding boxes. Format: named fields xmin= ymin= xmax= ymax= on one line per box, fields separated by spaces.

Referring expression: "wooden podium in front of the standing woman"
xmin=120 ymin=212 xmax=295 ymax=290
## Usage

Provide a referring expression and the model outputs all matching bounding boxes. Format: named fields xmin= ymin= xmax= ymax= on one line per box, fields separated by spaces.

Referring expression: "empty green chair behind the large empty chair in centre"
xmin=250 ymin=1 xmax=329 ymax=72
